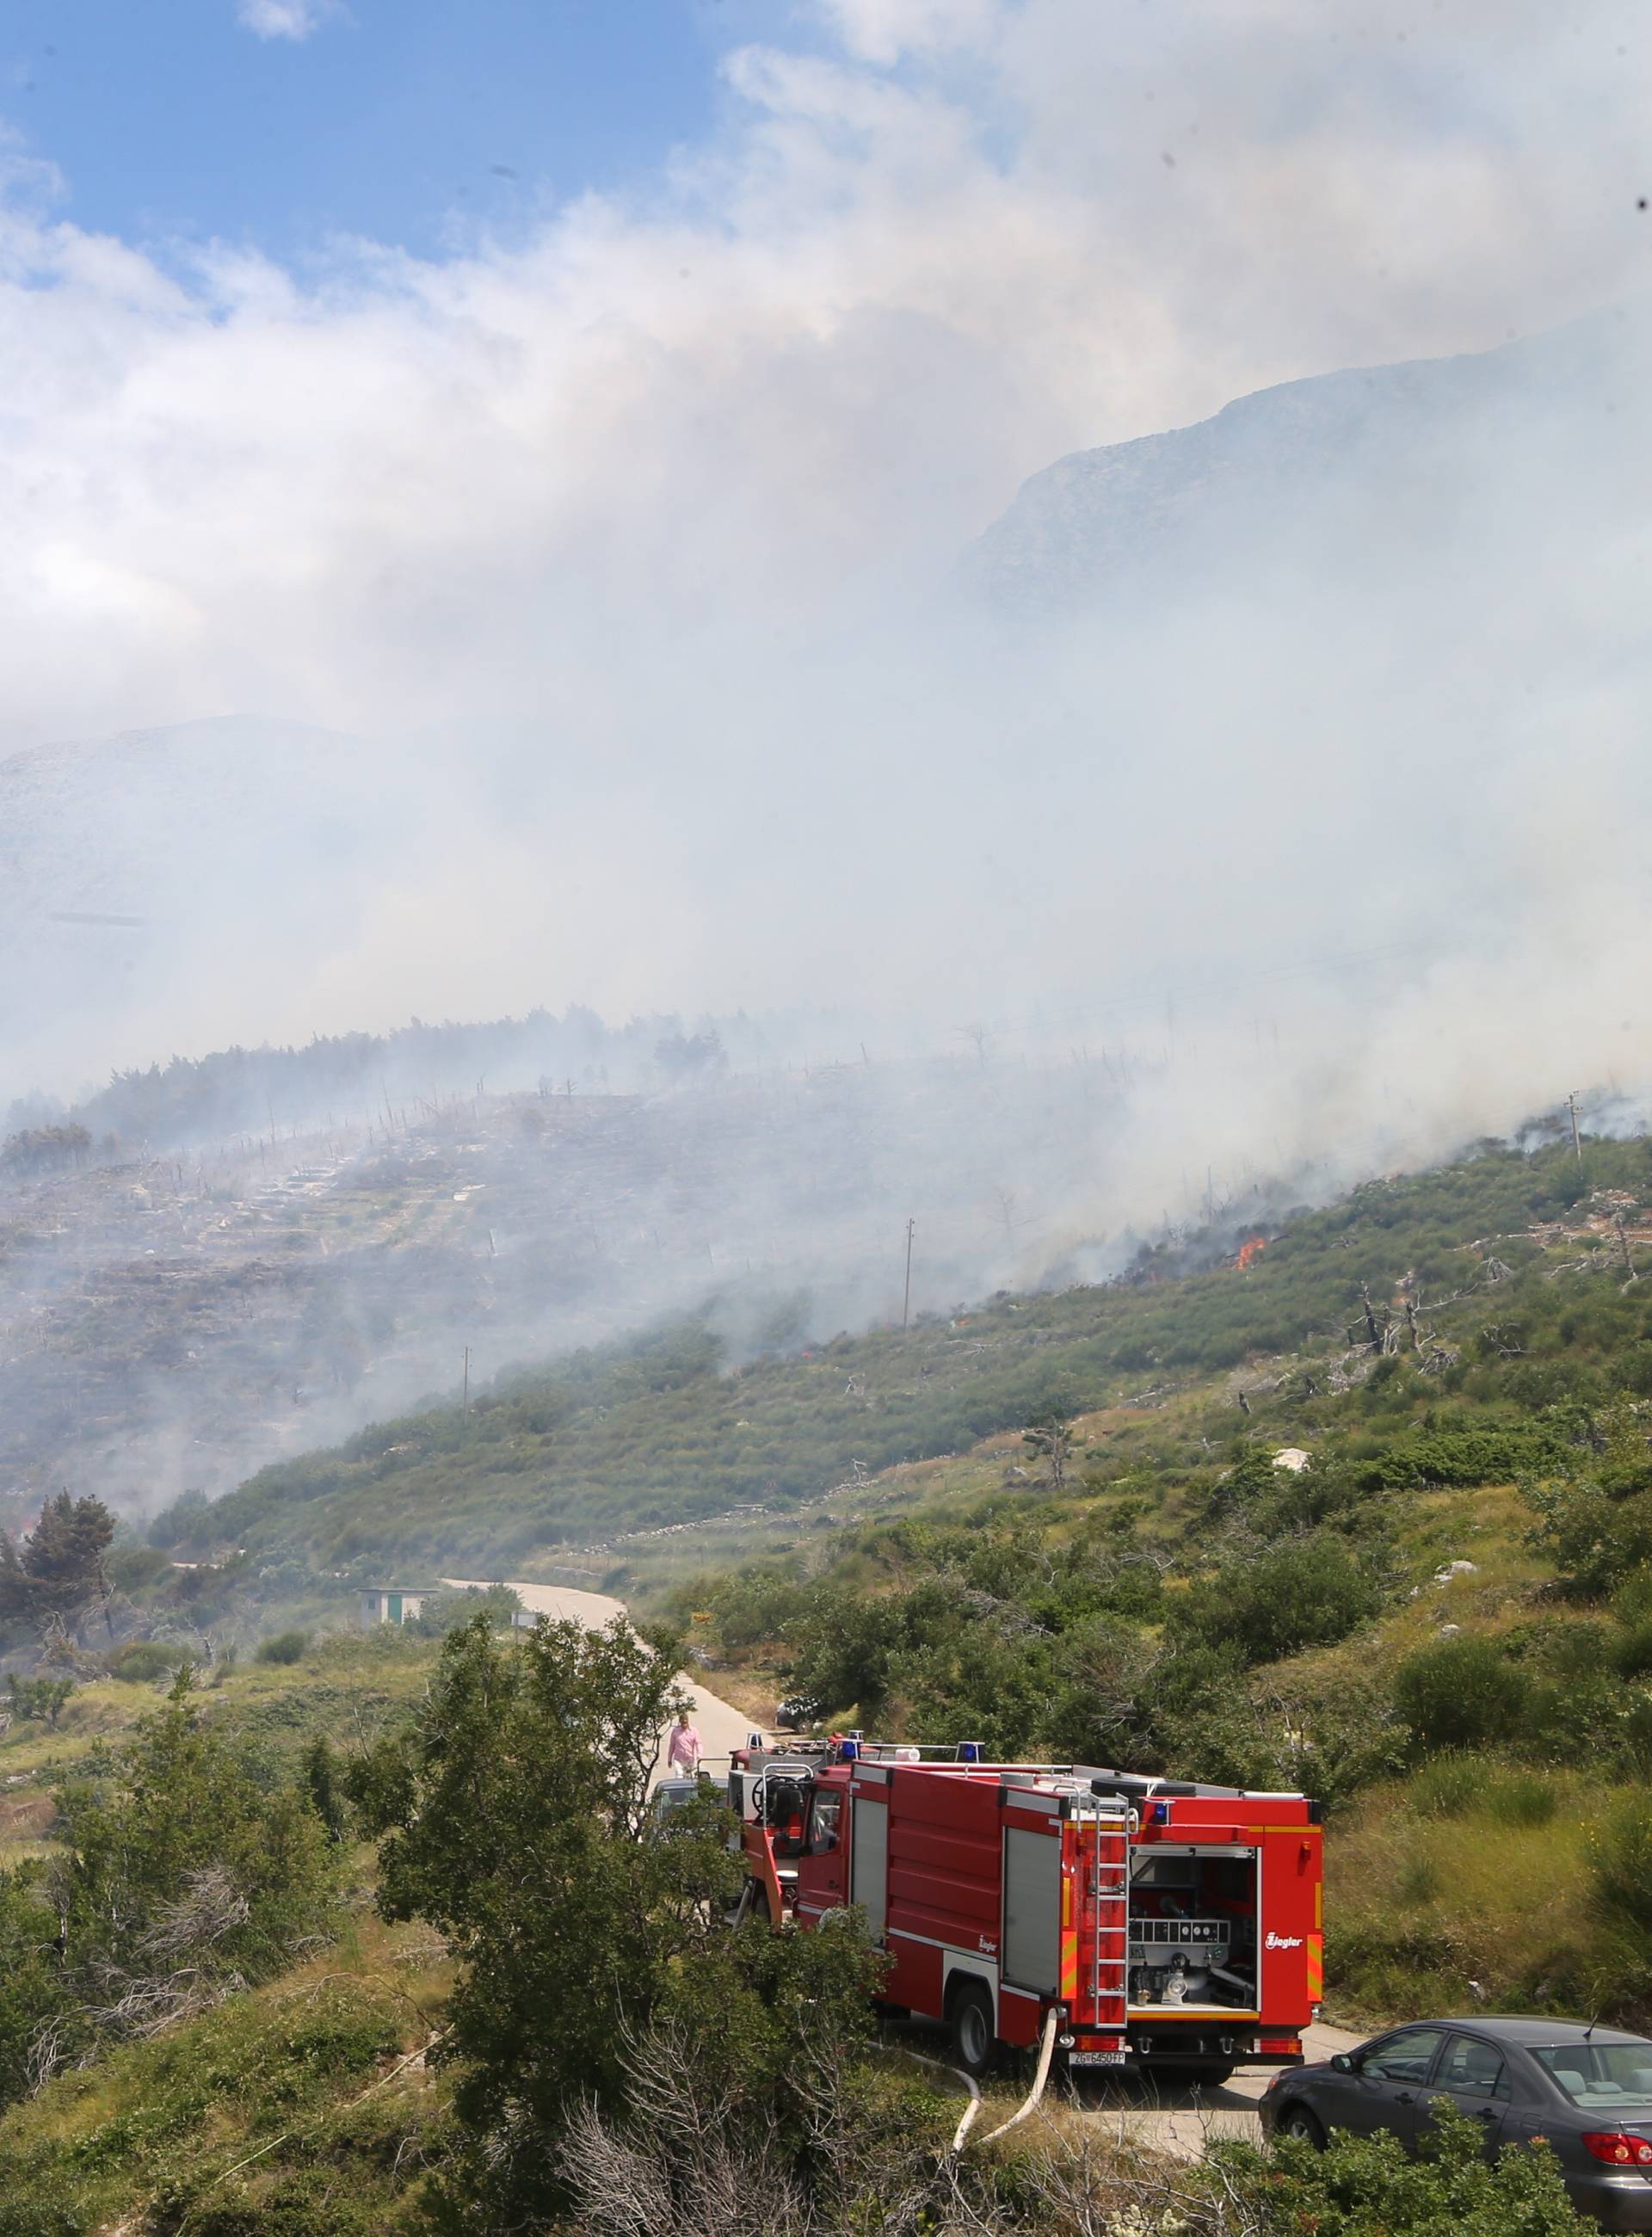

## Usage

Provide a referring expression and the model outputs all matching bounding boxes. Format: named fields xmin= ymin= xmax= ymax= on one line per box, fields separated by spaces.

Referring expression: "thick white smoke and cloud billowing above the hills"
xmin=0 ymin=0 xmax=1652 ymax=1208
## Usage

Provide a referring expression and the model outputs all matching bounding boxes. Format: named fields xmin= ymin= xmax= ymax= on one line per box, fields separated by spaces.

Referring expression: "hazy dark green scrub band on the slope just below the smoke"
xmin=164 ymin=1143 xmax=1652 ymax=1575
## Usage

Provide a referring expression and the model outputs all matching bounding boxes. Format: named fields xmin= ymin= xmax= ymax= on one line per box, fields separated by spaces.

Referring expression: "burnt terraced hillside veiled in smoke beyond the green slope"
xmin=0 ymin=1046 xmax=1119 ymax=1528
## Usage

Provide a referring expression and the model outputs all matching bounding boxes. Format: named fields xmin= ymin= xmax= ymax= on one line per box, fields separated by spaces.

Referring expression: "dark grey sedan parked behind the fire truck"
xmin=1261 ymin=2018 xmax=1652 ymax=2230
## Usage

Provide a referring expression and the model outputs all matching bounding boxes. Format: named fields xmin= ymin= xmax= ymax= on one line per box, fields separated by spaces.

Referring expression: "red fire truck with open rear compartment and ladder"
xmin=730 ymin=1734 xmax=1323 ymax=2085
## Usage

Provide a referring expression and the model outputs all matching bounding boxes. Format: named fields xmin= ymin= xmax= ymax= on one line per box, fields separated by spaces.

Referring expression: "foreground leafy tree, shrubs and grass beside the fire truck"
xmin=0 ymin=1615 xmax=1578 ymax=2237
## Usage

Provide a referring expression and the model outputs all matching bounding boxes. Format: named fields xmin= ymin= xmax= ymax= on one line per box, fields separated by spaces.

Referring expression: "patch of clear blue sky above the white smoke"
xmin=0 ymin=0 xmax=788 ymax=260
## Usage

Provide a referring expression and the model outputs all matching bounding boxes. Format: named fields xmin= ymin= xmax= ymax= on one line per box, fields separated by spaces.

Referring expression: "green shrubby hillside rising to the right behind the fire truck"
xmin=125 ymin=1118 xmax=1652 ymax=2049
